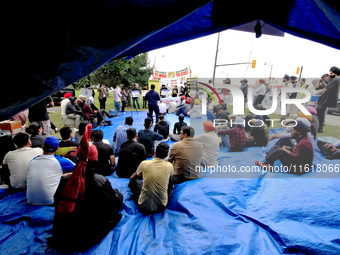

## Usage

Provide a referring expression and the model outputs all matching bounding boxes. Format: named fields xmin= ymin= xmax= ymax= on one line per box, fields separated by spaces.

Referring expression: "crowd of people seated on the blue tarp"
xmin=2 ymin=73 xmax=340 ymax=250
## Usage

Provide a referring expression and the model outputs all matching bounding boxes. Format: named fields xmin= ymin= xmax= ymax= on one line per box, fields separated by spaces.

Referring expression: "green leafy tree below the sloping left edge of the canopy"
xmin=74 ymin=53 xmax=152 ymax=88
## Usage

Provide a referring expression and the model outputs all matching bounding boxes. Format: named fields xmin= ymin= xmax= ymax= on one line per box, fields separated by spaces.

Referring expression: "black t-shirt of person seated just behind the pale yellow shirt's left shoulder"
xmin=116 ymin=141 xmax=146 ymax=178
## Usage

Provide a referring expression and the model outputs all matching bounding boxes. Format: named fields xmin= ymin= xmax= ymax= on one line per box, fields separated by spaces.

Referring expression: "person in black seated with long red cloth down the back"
xmin=47 ymin=124 xmax=123 ymax=251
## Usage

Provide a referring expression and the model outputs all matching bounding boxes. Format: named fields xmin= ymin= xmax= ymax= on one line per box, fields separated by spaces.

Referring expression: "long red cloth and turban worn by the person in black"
xmin=58 ymin=124 xmax=98 ymax=213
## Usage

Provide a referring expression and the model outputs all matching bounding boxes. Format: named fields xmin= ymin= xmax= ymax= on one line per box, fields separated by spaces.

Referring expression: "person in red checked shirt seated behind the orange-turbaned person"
xmin=218 ymin=117 xmax=246 ymax=152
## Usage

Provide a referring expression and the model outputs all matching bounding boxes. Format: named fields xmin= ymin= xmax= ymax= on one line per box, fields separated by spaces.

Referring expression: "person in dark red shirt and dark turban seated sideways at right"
xmin=255 ymin=121 xmax=314 ymax=175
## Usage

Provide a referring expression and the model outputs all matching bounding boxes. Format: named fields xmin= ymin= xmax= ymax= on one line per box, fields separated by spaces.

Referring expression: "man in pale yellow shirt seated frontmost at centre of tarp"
xmin=129 ymin=143 xmax=174 ymax=214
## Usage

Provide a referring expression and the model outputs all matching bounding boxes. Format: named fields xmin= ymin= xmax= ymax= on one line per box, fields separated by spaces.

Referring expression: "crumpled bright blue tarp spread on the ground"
xmin=0 ymin=112 xmax=340 ymax=255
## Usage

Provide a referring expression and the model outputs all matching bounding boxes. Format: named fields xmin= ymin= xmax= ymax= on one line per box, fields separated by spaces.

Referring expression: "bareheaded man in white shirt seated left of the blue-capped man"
xmin=2 ymin=133 xmax=43 ymax=189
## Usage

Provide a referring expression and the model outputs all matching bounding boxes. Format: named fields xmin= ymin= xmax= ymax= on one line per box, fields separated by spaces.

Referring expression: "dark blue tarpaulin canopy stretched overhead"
xmin=0 ymin=0 xmax=340 ymax=120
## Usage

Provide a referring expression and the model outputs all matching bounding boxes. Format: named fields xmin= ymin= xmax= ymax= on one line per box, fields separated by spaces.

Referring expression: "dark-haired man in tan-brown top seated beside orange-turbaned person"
xmin=168 ymin=126 xmax=203 ymax=183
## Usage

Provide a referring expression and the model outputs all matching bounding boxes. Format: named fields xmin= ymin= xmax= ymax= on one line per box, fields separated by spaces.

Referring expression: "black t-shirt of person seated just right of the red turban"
xmin=93 ymin=141 xmax=114 ymax=176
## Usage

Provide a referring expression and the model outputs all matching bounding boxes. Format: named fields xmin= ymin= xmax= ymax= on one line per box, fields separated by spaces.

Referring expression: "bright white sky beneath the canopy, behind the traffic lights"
xmin=148 ymin=30 xmax=340 ymax=80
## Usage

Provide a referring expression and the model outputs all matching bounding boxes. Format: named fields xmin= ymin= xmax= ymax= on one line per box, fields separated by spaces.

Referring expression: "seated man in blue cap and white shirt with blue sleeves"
xmin=27 ymin=136 xmax=75 ymax=205
